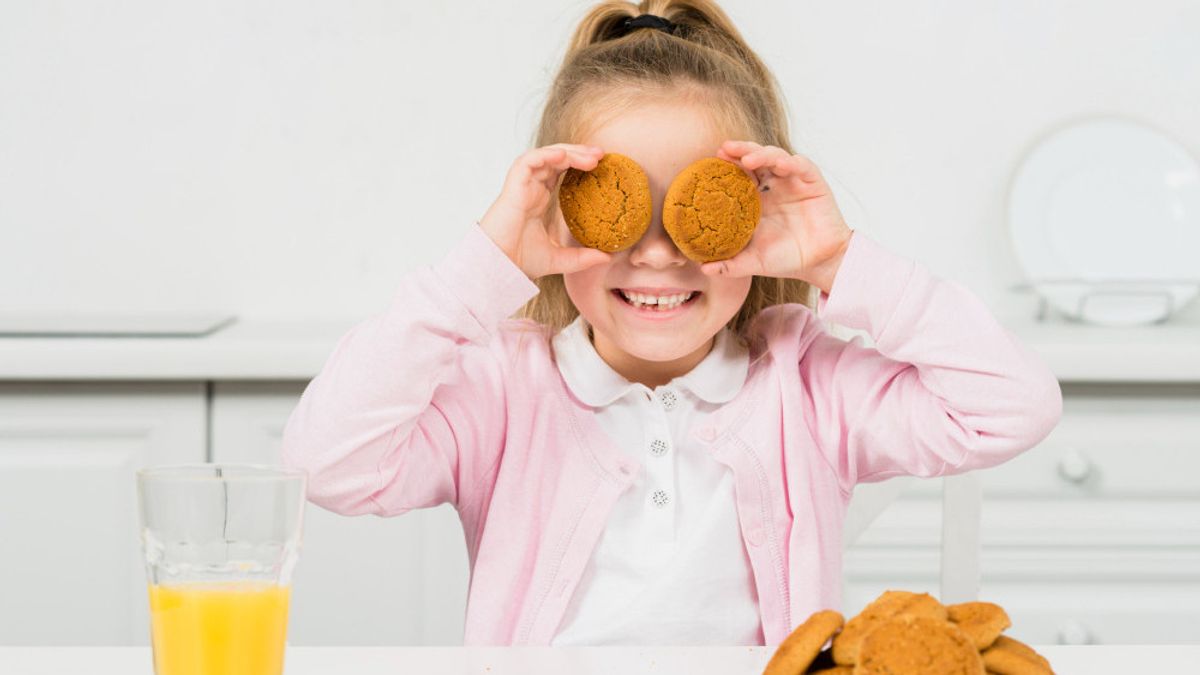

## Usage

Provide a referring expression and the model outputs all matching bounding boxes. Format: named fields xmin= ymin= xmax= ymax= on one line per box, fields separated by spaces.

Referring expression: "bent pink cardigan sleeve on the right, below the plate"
xmin=799 ymin=232 xmax=1062 ymax=491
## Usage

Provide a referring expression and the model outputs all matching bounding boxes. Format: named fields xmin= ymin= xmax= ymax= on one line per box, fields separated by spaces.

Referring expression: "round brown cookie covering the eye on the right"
xmin=662 ymin=157 xmax=762 ymax=263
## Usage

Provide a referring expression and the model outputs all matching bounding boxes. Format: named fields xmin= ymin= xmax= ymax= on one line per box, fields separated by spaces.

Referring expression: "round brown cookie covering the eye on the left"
xmin=558 ymin=153 xmax=654 ymax=253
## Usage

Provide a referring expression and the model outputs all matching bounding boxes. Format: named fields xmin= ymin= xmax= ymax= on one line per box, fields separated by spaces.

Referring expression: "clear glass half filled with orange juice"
xmin=137 ymin=464 xmax=306 ymax=675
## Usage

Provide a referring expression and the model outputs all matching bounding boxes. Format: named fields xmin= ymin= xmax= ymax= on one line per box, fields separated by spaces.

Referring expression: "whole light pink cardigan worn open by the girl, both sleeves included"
xmin=282 ymin=226 xmax=1062 ymax=645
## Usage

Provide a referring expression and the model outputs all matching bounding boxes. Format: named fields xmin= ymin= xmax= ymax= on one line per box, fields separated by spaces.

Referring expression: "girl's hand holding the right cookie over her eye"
xmin=701 ymin=141 xmax=852 ymax=293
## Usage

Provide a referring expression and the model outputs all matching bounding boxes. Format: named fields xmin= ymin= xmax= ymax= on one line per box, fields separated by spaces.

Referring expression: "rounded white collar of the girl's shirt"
xmin=553 ymin=316 xmax=750 ymax=407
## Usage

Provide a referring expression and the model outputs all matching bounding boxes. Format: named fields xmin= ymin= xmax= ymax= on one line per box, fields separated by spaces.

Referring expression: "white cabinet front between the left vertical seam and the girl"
xmin=211 ymin=382 xmax=468 ymax=645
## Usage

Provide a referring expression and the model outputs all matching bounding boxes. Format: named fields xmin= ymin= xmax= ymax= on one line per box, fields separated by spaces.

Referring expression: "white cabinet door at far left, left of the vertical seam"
xmin=0 ymin=382 xmax=205 ymax=645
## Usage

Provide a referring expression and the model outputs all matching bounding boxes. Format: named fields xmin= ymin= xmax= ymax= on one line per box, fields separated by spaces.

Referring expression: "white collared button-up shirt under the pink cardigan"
xmin=551 ymin=317 xmax=763 ymax=645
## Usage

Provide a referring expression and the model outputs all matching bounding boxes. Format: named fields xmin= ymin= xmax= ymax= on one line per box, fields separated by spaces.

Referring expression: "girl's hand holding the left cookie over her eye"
xmin=479 ymin=143 xmax=611 ymax=279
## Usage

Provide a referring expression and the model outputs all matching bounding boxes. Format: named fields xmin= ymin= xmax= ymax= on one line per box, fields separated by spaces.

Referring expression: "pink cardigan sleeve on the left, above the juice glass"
xmin=282 ymin=225 xmax=538 ymax=515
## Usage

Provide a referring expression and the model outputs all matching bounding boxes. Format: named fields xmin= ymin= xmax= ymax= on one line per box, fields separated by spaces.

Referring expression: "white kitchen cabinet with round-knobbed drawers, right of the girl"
xmin=844 ymin=384 xmax=1200 ymax=644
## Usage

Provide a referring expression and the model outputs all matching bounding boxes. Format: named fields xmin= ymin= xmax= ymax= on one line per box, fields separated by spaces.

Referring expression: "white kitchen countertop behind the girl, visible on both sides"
xmin=0 ymin=297 xmax=1200 ymax=383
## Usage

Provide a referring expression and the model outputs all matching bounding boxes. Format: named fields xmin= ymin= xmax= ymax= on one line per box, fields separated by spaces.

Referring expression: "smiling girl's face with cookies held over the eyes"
xmin=554 ymin=102 xmax=751 ymax=367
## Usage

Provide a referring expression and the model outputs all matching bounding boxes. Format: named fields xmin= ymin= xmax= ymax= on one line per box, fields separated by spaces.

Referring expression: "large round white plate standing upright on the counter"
xmin=1008 ymin=119 xmax=1200 ymax=325
